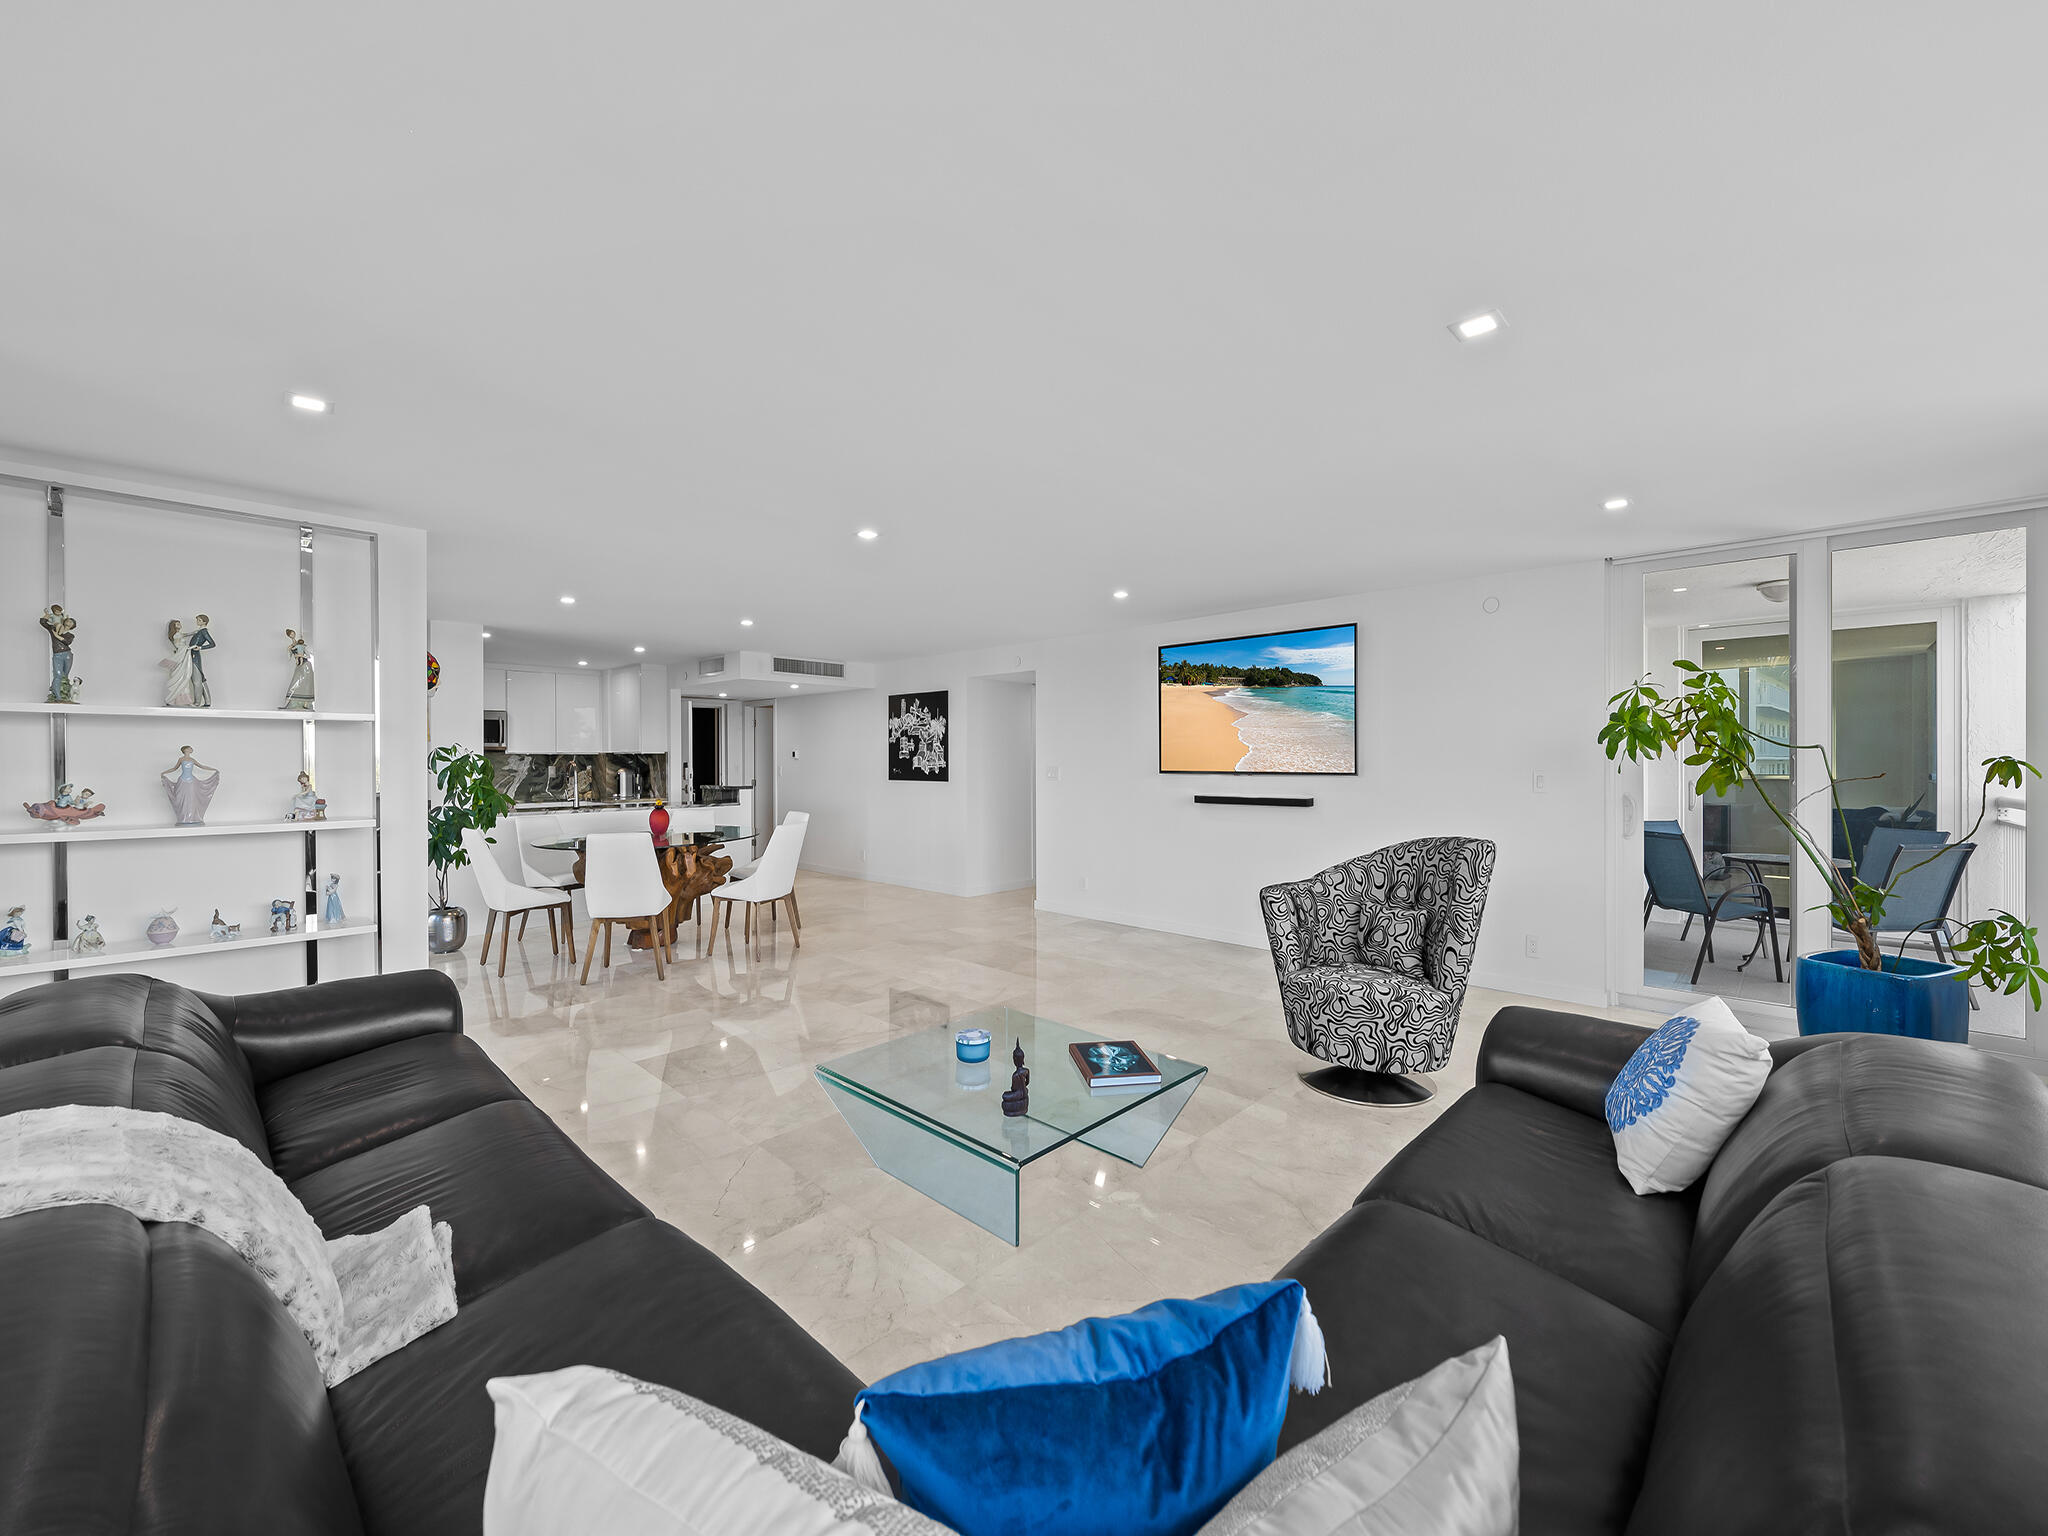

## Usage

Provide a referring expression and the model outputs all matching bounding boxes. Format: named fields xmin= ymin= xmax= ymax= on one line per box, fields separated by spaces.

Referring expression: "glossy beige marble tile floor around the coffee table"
xmin=436 ymin=874 xmax=1654 ymax=1380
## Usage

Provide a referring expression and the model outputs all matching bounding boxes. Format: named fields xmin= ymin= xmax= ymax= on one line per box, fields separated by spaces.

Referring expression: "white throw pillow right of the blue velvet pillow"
xmin=1200 ymin=1337 xmax=1522 ymax=1536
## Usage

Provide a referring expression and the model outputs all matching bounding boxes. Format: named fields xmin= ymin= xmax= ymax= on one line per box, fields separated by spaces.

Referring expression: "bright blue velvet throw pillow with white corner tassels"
xmin=838 ymin=1280 xmax=1327 ymax=1536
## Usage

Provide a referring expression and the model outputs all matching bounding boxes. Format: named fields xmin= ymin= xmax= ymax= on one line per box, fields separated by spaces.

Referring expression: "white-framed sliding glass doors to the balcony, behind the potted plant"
xmin=1608 ymin=510 xmax=2048 ymax=1059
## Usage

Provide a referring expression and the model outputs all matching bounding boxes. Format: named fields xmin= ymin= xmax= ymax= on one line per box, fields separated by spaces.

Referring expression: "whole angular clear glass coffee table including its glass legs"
xmin=817 ymin=1008 xmax=1208 ymax=1243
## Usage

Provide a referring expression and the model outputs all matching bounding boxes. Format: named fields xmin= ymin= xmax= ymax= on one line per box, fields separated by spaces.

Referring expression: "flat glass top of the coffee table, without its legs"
xmin=817 ymin=1008 xmax=1208 ymax=1171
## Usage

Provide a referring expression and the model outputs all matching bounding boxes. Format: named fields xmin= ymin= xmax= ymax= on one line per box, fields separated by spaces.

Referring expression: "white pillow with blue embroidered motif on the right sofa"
xmin=1608 ymin=997 xmax=1772 ymax=1194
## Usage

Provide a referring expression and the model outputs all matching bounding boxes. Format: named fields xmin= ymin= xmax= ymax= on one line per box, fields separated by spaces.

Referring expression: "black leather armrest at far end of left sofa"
xmin=201 ymin=971 xmax=463 ymax=1087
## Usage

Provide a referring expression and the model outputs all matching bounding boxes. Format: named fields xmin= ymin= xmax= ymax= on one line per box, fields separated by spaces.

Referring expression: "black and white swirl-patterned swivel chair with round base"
xmin=1260 ymin=838 xmax=1493 ymax=1104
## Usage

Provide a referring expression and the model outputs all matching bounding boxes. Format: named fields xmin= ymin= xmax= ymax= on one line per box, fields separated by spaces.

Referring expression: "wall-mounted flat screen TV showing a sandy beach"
xmin=1159 ymin=625 xmax=1358 ymax=774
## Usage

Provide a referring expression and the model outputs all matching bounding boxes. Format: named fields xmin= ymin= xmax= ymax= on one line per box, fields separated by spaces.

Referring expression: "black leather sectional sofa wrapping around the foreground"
xmin=0 ymin=973 xmax=2048 ymax=1536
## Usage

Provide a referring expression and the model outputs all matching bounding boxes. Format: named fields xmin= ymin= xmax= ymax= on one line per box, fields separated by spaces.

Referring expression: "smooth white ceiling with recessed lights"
xmin=0 ymin=10 xmax=2048 ymax=666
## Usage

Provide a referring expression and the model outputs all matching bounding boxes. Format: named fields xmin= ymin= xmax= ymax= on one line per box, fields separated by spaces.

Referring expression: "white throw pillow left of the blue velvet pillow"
xmin=483 ymin=1366 xmax=954 ymax=1536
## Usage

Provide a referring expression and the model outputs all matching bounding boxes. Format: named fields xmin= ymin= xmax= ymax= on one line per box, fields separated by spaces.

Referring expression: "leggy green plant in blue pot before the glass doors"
xmin=1599 ymin=662 xmax=2048 ymax=1038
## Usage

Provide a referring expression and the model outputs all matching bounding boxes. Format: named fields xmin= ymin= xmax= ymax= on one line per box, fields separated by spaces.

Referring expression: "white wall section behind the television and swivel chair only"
xmin=1038 ymin=561 xmax=1612 ymax=1004
